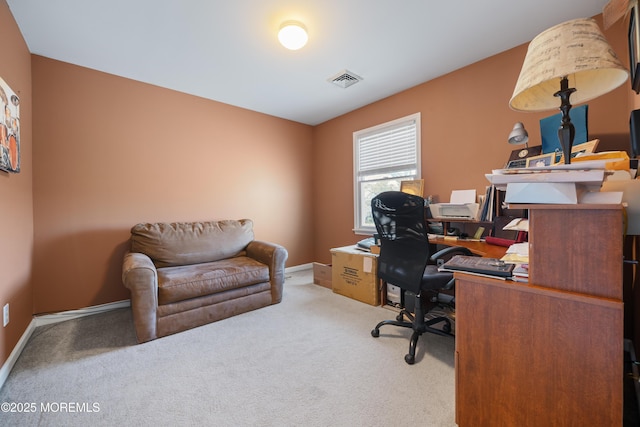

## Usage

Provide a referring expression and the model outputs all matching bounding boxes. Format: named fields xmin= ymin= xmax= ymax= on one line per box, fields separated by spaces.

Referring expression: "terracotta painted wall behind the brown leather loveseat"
xmin=32 ymin=56 xmax=313 ymax=314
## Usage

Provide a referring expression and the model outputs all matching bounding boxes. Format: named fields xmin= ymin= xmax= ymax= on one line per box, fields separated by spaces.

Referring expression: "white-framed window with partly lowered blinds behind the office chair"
xmin=353 ymin=113 xmax=421 ymax=234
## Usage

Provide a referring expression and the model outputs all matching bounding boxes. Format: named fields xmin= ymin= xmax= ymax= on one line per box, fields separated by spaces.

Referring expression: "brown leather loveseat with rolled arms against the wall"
xmin=122 ymin=219 xmax=288 ymax=343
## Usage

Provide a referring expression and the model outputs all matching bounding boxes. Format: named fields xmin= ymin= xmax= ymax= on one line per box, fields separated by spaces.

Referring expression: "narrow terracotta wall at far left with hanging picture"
xmin=0 ymin=0 xmax=33 ymax=366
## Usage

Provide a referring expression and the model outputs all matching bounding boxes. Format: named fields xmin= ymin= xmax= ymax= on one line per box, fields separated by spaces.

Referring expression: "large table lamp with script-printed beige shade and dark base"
xmin=509 ymin=18 xmax=629 ymax=164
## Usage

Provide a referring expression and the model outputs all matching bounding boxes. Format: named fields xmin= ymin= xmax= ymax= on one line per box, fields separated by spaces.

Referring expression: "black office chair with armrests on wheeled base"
xmin=371 ymin=191 xmax=472 ymax=365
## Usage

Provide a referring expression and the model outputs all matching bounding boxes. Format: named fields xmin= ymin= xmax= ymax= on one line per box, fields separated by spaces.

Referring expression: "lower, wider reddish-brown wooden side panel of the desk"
xmin=456 ymin=276 xmax=623 ymax=427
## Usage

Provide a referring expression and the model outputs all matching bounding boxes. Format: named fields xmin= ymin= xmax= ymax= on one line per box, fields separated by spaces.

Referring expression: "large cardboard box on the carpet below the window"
xmin=331 ymin=246 xmax=380 ymax=305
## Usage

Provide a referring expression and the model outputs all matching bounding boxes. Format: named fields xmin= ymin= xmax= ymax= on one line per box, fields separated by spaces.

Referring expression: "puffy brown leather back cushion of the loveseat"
xmin=131 ymin=219 xmax=254 ymax=268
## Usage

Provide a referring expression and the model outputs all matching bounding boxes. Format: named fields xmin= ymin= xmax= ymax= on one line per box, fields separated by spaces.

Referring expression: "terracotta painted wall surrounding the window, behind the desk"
xmin=313 ymin=16 xmax=633 ymax=263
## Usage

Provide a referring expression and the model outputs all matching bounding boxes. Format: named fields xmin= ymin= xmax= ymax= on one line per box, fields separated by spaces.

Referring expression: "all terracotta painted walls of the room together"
xmin=0 ymin=4 xmax=639 ymax=372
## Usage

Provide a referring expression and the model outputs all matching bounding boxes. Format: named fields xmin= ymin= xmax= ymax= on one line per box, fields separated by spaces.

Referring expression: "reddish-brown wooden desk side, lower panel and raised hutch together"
xmin=455 ymin=205 xmax=624 ymax=427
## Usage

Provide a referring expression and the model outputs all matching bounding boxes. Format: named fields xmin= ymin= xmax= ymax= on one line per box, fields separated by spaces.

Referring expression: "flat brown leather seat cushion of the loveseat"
xmin=158 ymin=256 xmax=269 ymax=305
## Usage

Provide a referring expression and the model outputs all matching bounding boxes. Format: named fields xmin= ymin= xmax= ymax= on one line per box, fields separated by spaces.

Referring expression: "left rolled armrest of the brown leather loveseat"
xmin=122 ymin=252 xmax=158 ymax=343
